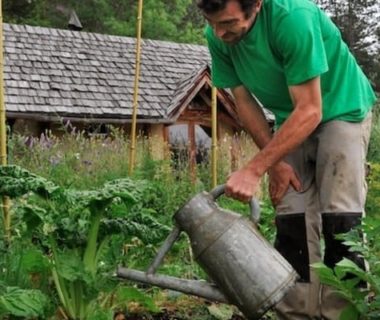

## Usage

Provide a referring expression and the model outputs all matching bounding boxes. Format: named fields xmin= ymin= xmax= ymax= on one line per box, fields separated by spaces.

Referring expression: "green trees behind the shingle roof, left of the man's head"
xmin=4 ymin=0 xmax=204 ymax=43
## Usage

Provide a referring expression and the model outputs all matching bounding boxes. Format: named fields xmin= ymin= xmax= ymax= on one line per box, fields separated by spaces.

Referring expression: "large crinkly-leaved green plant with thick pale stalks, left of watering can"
xmin=0 ymin=166 xmax=162 ymax=320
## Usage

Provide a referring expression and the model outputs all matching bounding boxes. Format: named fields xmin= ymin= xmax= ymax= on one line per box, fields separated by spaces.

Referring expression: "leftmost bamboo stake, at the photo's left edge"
xmin=0 ymin=0 xmax=11 ymax=242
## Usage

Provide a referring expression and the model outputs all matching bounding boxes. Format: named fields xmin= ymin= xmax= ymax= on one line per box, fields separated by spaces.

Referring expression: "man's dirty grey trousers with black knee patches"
xmin=275 ymin=114 xmax=371 ymax=320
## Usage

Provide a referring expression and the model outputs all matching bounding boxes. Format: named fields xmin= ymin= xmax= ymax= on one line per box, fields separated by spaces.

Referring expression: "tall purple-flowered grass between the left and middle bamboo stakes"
xmin=8 ymin=127 xmax=129 ymax=189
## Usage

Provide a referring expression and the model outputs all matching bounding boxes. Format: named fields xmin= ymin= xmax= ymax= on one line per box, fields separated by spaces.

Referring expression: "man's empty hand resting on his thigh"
xmin=268 ymin=161 xmax=302 ymax=206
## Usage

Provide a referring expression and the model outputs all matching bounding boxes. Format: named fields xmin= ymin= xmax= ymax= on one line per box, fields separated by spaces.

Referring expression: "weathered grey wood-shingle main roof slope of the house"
xmin=4 ymin=24 xmax=209 ymax=121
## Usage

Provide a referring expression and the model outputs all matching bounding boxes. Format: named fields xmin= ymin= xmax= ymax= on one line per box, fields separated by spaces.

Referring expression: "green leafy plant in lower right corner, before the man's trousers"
xmin=312 ymin=218 xmax=380 ymax=320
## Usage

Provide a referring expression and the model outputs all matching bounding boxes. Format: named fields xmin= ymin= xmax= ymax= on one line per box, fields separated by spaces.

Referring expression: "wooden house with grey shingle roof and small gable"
xmin=4 ymin=24 xmax=274 ymax=162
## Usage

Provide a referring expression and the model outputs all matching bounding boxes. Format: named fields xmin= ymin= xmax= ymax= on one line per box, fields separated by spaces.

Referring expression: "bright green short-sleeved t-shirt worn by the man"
xmin=206 ymin=0 xmax=376 ymax=125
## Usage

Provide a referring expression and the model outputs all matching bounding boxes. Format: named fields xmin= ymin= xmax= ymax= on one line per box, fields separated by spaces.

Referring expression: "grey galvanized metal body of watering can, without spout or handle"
xmin=174 ymin=192 xmax=297 ymax=319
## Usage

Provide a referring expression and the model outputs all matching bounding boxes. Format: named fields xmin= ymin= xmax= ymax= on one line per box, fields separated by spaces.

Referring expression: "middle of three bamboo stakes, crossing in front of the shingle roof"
xmin=129 ymin=0 xmax=143 ymax=175
